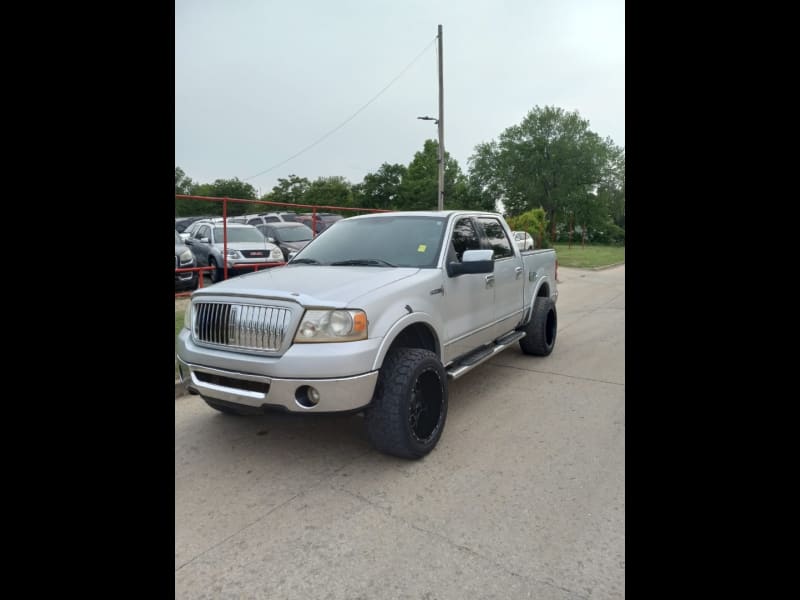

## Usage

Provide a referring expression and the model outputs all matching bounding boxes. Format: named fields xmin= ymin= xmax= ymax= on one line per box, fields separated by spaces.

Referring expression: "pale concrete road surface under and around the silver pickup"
xmin=175 ymin=266 xmax=625 ymax=600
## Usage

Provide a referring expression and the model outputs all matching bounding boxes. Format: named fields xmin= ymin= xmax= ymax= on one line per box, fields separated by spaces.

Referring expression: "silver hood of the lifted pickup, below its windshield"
xmin=192 ymin=265 xmax=419 ymax=308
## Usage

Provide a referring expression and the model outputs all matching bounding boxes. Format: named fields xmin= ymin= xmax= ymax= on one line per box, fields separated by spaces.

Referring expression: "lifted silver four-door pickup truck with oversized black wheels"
xmin=177 ymin=211 xmax=558 ymax=459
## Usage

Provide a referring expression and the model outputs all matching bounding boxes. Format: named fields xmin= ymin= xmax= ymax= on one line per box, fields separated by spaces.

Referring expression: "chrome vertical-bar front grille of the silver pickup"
xmin=192 ymin=302 xmax=291 ymax=352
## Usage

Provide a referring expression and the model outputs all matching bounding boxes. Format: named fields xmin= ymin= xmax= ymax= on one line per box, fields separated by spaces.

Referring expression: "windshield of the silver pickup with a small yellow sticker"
xmin=292 ymin=215 xmax=446 ymax=268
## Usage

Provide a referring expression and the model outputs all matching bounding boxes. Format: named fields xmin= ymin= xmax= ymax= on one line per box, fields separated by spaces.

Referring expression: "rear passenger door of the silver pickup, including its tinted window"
xmin=477 ymin=216 xmax=525 ymax=339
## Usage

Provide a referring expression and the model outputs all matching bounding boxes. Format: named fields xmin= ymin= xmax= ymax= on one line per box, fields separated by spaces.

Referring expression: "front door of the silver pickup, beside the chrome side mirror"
xmin=442 ymin=217 xmax=496 ymax=363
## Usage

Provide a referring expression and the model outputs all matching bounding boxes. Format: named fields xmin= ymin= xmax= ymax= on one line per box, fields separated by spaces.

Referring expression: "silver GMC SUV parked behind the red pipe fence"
xmin=186 ymin=221 xmax=283 ymax=283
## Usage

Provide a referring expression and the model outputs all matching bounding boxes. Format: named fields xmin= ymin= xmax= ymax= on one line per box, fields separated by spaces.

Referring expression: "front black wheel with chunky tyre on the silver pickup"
xmin=365 ymin=348 xmax=447 ymax=459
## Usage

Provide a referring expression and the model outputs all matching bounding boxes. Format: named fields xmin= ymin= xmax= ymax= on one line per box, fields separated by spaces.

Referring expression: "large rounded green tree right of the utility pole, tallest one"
xmin=470 ymin=106 xmax=612 ymax=236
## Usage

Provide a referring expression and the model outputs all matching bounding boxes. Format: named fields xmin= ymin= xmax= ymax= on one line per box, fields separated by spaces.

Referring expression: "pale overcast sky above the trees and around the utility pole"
xmin=175 ymin=0 xmax=625 ymax=194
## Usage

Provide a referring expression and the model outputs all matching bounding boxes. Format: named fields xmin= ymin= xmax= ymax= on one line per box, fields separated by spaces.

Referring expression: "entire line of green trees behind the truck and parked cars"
xmin=175 ymin=106 xmax=625 ymax=240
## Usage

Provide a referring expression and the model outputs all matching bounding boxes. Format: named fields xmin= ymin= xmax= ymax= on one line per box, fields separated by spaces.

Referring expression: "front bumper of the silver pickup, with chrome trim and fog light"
xmin=178 ymin=357 xmax=378 ymax=413
